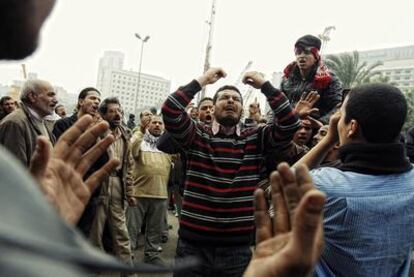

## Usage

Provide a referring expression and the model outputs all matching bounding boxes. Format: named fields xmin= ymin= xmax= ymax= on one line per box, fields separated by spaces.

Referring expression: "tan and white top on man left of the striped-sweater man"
xmin=127 ymin=130 xmax=171 ymax=199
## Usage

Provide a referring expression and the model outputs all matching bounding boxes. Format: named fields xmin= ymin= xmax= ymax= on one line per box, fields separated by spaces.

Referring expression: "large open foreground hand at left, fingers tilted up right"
xmin=30 ymin=115 xmax=119 ymax=224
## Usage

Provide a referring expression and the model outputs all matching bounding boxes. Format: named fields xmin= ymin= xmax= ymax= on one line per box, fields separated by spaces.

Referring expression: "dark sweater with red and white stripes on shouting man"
xmin=162 ymin=80 xmax=300 ymax=246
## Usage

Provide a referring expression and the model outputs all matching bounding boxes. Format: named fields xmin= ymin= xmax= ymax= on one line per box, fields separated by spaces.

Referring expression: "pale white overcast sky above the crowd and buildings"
xmin=0 ymin=0 xmax=414 ymax=97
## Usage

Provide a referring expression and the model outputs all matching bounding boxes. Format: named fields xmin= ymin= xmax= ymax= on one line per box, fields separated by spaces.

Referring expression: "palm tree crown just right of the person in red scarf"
xmin=325 ymin=51 xmax=382 ymax=88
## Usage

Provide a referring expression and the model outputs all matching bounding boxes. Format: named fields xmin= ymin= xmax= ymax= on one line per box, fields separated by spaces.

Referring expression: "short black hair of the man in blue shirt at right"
xmin=344 ymin=84 xmax=407 ymax=143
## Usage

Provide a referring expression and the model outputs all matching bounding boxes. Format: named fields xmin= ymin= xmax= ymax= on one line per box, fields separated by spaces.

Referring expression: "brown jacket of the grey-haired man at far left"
xmin=0 ymin=103 xmax=55 ymax=167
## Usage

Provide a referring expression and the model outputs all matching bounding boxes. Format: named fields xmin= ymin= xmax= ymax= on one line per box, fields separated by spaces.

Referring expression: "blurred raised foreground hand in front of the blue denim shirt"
xmin=244 ymin=163 xmax=325 ymax=277
